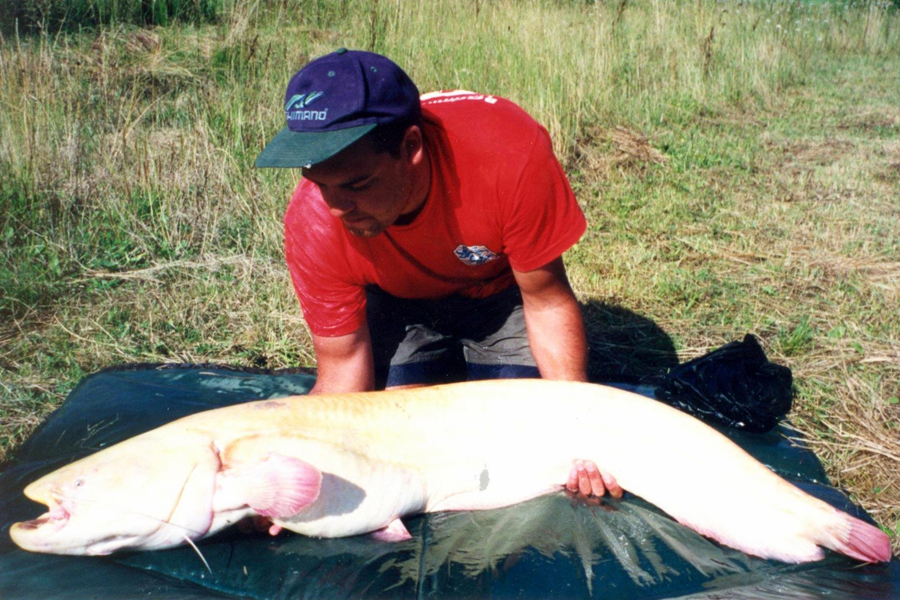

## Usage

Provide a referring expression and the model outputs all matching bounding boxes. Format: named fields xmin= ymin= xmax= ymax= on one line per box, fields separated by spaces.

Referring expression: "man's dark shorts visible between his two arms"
xmin=366 ymin=286 xmax=540 ymax=389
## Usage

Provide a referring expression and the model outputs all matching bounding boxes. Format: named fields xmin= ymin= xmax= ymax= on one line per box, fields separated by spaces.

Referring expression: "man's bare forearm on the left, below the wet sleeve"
xmin=309 ymin=324 xmax=375 ymax=394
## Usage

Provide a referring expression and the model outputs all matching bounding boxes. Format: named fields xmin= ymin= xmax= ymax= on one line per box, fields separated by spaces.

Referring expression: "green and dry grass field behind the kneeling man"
xmin=0 ymin=0 xmax=900 ymax=550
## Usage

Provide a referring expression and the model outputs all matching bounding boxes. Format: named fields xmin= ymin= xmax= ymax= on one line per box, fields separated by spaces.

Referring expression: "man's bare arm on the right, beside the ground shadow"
xmin=513 ymin=257 xmax=587 ymax=381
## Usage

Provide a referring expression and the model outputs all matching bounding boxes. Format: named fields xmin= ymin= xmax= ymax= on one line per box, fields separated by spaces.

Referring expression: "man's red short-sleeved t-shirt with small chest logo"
xmin=284 ymin=91 xmax=586 ymax=337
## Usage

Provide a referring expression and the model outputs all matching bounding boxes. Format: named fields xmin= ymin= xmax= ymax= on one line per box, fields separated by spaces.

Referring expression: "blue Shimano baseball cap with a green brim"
xmin=256 ymin=48 xmax=421 ymax=168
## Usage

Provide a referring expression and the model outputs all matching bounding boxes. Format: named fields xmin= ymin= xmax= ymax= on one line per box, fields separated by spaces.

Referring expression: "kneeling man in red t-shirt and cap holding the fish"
xmin=256 ymin=49 xmax=621 ymax=496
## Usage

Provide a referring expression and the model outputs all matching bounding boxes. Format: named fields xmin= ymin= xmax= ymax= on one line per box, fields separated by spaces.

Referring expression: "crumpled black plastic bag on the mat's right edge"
xmin=656 ymin=334 xmax=793 ymax=433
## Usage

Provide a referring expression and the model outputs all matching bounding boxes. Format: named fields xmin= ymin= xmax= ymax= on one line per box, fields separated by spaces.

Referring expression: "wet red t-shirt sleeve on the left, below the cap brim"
xmin=284 ymin=182 xmax=366 ymax=337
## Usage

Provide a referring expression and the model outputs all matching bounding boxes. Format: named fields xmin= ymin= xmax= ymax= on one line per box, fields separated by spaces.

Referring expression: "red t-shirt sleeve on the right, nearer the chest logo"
xmin=503 ymin=127 xmax=587 ymax=271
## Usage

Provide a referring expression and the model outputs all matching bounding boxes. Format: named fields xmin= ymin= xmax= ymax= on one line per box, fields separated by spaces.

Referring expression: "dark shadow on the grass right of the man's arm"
xmin=581 ymin=302 xmax=678 ymax=385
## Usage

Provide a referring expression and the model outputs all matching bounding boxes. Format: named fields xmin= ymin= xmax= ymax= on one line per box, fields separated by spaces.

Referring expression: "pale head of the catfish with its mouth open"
xmin=10 ymin=440 xmax=219 ymax=555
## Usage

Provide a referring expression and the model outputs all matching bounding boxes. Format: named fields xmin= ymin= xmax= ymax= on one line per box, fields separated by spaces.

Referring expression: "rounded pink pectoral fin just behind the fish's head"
xmin=241 ymin=454 xmax=322 ymax=518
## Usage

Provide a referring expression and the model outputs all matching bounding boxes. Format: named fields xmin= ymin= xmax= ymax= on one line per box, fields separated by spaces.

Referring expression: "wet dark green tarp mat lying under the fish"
xmin=0 ymin=366 xmax=900 ymax=600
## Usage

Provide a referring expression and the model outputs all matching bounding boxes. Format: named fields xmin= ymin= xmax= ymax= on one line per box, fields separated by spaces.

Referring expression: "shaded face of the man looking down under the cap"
xmin=303 ymin=138 xmax=416 ymax=238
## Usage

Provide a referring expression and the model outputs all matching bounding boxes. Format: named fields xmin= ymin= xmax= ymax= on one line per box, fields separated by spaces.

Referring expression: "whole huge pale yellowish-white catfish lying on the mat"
xmin=10 ymin=380 xmax=891 ymax=563
